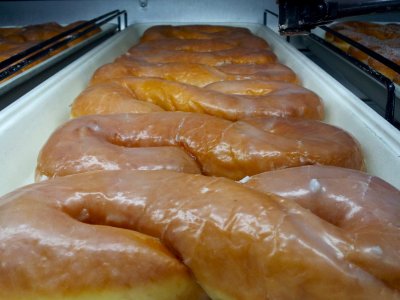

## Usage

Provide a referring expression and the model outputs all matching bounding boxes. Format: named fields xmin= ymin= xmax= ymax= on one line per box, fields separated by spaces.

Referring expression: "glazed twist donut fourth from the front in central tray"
xmin=90 ymin=60 xmax=297 ymax=87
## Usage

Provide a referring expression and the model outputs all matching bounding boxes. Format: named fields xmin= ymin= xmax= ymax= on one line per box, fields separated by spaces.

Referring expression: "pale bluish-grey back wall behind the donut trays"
xmin=0 ymin=0 xmax=277 ymax=26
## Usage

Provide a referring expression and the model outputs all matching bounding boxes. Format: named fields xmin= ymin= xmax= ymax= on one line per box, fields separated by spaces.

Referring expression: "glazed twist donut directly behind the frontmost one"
xmin=36 ymin=112 xmax=364 ymax=180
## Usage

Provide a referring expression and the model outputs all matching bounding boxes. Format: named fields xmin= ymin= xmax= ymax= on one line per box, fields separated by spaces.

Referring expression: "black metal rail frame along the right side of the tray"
xmin=309 ymin=26 xmax=400 ymax=126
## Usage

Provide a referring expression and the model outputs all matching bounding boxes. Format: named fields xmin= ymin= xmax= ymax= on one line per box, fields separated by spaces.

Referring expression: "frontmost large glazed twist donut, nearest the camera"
xmin=0 ymin=171 xmax=400 ymax=300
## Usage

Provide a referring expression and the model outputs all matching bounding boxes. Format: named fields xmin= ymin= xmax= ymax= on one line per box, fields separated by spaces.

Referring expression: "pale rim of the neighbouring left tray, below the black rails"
xmin=0 ymin=23 xmax=117 ymax=95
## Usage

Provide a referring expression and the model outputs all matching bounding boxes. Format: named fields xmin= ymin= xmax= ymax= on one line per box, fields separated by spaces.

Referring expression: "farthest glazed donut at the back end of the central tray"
xmin=140 ymin=25 xmax=252 ymax=43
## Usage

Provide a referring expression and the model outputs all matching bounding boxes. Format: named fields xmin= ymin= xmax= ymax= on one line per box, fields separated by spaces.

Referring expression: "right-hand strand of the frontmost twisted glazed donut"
xmin=243 ymin=166 xmax=400 ymax=289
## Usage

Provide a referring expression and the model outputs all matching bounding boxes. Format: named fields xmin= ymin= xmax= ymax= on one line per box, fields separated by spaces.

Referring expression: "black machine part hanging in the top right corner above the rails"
xmin=279 ymin=0 xmax=400 ymax=35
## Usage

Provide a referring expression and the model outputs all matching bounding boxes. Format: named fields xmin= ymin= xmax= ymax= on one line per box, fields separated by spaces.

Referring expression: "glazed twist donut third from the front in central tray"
xmin=71 ymin=77 xmax=323 ymax=121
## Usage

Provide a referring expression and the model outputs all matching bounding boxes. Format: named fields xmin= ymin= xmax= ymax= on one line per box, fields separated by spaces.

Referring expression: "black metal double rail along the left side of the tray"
xmin=0 ymin=10 xmax=128 ymax=80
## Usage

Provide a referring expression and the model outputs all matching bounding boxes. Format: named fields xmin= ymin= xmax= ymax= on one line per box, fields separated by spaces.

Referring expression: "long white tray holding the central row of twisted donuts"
xmin=0 ymin=23 xmax=400 ymax=195
